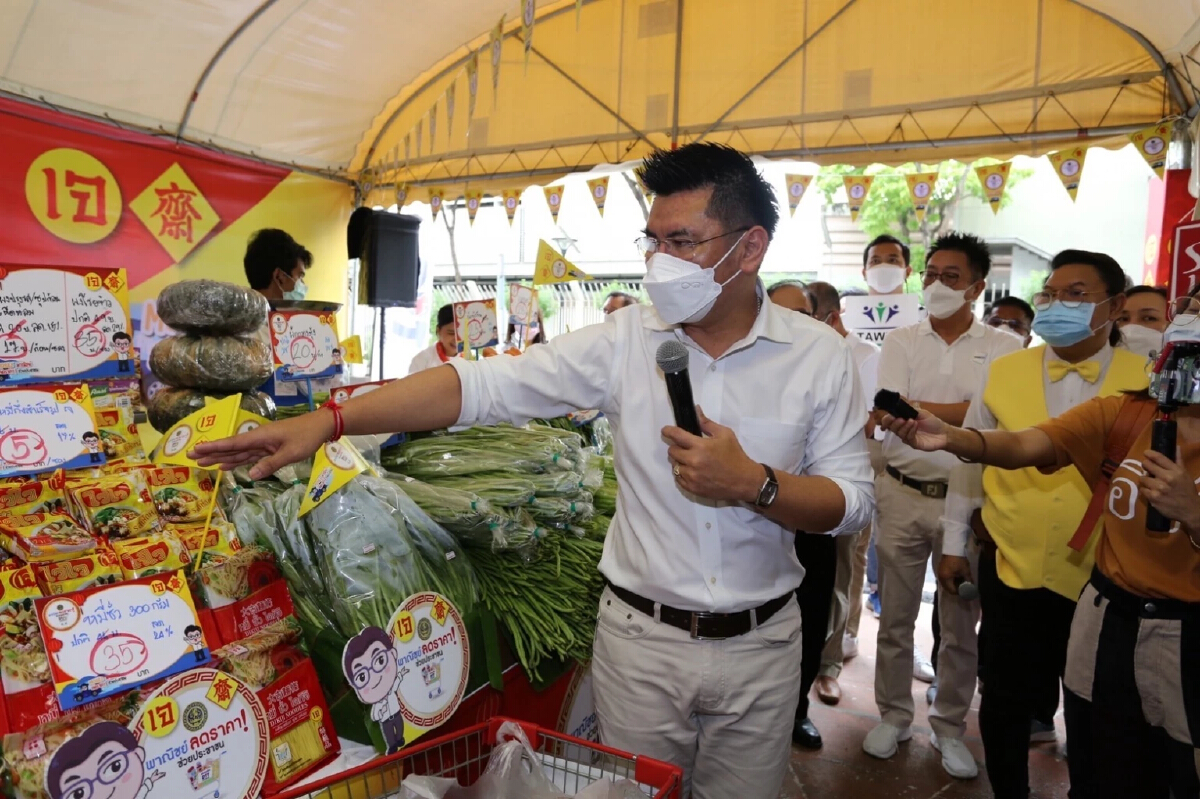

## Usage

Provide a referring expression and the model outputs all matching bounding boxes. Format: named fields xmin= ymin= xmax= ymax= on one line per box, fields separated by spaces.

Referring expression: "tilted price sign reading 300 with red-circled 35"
xmin=36 ymin=572 xmax=209 ymax=710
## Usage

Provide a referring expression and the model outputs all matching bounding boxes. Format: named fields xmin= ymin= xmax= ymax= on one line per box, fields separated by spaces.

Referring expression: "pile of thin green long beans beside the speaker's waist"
xmin=472 ymin=531 xmax=604 ymax=679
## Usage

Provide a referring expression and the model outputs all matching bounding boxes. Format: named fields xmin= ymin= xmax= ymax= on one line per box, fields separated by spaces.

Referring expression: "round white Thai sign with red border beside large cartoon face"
xmin=130 ymin=668 xmax=271 ymax=799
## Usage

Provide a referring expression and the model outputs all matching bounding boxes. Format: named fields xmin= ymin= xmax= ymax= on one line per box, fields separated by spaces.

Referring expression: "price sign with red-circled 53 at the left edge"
xmin=0 ymin=384 xmax=104 ymax=477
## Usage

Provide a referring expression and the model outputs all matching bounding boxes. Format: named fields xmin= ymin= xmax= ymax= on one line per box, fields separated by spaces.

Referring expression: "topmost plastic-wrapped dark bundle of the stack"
xmin=155 ymin=281 xmax=270 ymax=333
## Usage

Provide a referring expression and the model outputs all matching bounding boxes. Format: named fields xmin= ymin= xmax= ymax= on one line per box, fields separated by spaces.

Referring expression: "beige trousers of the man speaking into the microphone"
xmin=592 ymin=589 xmax=800 ymax=799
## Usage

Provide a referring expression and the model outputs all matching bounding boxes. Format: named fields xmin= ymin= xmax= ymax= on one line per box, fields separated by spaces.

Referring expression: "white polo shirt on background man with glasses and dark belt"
xmin=878 ymin=319 xmax=1021 ymax=482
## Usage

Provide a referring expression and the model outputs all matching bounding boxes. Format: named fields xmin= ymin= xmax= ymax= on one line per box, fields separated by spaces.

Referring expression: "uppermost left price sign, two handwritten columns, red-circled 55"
xmin=0 ymin=266 xmax=133 ymax=384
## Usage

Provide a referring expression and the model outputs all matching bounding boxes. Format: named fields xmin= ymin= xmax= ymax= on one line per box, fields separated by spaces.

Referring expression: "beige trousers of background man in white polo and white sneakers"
xmin=875 ymin=475 xmax=979 ymax=738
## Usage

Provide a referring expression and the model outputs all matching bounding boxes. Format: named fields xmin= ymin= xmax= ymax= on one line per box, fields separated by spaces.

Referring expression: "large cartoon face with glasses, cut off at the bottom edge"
xmin=46 ymin=721 xmax=167 ymax=799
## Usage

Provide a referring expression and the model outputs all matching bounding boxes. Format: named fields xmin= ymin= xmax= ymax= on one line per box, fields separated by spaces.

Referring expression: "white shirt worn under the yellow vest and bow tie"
xmin=942 ymin=344 xmax=1112 ymax=558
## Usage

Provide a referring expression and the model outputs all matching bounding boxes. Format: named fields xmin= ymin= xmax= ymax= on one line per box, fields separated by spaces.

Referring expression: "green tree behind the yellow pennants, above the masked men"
xmin=816 ymin=158 xmax=1033 ymax=274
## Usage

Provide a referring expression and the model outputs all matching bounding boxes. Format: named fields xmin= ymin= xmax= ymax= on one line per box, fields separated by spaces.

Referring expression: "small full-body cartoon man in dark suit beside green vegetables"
xmin=345 ymin=627 xmax=404 ymax=748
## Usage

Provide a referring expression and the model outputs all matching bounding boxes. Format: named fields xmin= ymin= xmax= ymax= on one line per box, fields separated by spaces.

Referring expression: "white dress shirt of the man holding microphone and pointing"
xmin=451 ymin=292 xmax=875 ymax=612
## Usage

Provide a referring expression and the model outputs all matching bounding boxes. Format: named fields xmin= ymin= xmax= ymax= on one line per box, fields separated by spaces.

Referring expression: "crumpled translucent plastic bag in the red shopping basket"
xmin=400 ymin=721 xmax=568 ymax=799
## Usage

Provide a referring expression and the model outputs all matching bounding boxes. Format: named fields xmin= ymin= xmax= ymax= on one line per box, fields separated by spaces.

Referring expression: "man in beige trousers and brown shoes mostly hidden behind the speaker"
xmin=802 ymin=281 xmax=880 ymax=704
